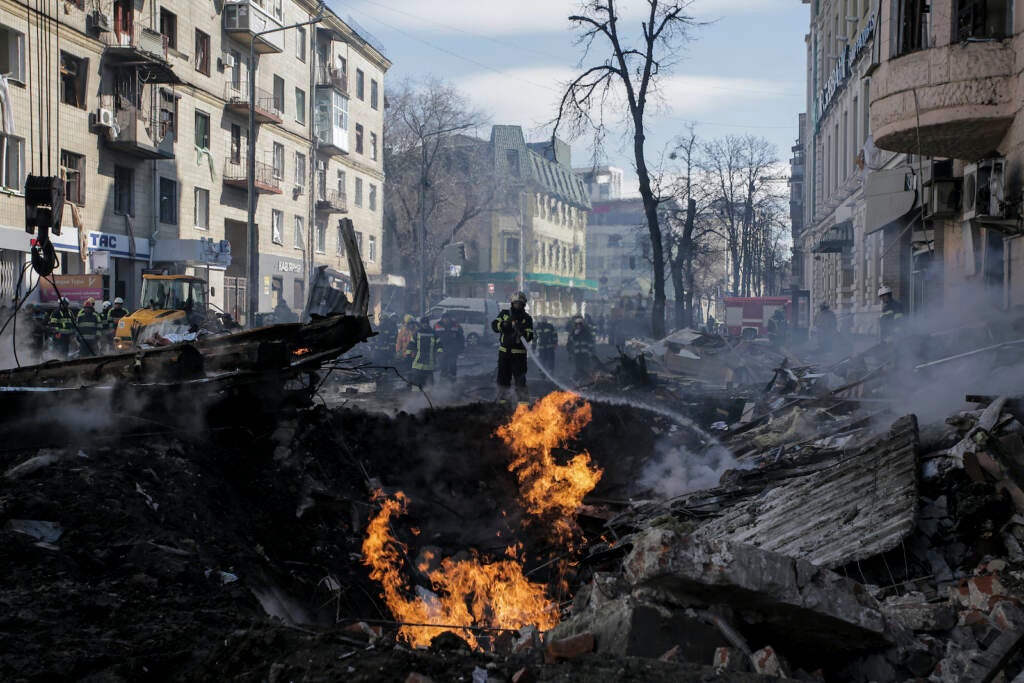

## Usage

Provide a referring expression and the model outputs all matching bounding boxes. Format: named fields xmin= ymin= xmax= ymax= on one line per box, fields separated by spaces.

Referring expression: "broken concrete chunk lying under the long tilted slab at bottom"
xmin=548 ymin=595 xmax=729 ymax=664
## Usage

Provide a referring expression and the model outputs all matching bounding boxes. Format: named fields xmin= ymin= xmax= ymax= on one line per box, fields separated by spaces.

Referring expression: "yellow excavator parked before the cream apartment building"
xmin=114 ymin=273 xmax=208 ymax=351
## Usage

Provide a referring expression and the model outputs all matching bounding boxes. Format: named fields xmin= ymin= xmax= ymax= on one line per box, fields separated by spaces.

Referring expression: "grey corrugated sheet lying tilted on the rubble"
xmin=697 ymin=416 xmax=918 ymax=568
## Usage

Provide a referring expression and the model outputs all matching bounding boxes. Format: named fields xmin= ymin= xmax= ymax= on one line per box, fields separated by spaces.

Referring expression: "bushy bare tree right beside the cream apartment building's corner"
xmin=384 ymin=78 xmax=496 ymax=312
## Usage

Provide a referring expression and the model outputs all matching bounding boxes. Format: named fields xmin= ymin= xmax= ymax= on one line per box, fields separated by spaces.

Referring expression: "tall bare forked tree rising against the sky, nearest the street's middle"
xmin=552 ymin=0 xmax=696 ymax=337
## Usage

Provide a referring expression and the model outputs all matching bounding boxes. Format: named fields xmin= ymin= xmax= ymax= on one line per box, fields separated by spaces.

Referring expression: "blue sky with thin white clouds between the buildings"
xmin=339 ymin=0 xmax=809 ymax=195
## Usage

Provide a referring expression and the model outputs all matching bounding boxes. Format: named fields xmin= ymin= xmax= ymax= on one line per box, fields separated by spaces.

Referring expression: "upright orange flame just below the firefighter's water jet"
xmin=497 ymin=391 xmax=603 ymax=548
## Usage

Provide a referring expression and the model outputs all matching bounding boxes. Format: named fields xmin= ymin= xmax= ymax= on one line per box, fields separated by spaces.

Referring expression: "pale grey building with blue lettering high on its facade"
xmin=794 ymin=0 xmax=914 ymax=333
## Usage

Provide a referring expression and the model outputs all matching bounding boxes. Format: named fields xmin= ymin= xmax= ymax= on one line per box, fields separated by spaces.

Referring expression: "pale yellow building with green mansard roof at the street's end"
xmin=447 ymin=126 xmax=597 ymax=317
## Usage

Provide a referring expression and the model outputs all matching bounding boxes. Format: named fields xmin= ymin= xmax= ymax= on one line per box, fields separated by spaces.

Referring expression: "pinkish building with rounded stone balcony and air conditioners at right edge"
xmin=870 ymin=0 xmax=1024 ymax=323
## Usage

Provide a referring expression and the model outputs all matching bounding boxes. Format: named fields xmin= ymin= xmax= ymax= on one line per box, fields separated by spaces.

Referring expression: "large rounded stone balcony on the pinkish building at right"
xmin=870 ymin=41 xmax=1018 ymax=160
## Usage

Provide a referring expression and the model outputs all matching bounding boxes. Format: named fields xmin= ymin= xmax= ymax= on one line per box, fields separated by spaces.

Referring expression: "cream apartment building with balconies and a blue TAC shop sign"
xmin=0 ymin=0 xmax=390 ymax=322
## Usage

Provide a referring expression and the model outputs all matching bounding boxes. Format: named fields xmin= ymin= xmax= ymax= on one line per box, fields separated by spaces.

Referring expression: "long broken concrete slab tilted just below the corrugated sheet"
xmin=623 ymin=528 xmax=888 ymax=661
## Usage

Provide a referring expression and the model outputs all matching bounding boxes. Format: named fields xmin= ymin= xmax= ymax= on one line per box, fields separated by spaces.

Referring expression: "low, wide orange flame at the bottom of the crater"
xmin=362 ymin=492 xmax=558 ymax=647
